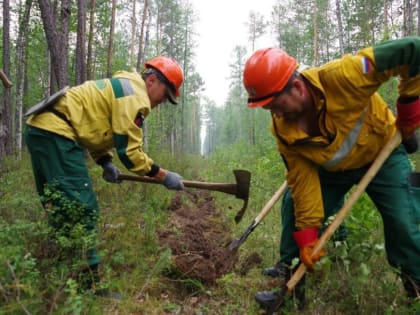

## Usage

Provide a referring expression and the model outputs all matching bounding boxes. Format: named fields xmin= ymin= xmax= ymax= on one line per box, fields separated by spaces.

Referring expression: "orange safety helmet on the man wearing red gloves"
xmin=243 ymin=48 xmax=298 ymax=107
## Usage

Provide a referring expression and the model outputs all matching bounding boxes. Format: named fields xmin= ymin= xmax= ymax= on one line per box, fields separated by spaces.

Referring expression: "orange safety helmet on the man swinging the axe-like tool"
xmin=144 ymin=56 xmax=184 ymax=104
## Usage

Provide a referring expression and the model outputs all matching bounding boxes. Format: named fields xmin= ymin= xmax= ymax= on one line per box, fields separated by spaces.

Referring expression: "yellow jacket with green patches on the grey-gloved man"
xmin=27 ymin=71 xmax=153 ymax=175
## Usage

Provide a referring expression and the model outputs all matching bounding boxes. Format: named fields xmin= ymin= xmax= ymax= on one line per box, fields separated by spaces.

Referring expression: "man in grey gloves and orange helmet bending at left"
xmin=25 ymin=56 xmax=184 ymax=296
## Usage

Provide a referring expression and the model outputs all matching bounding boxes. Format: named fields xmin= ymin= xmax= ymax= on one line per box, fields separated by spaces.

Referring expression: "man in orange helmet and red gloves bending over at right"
xmin=243 ymin=37 xmax=420 ymax=311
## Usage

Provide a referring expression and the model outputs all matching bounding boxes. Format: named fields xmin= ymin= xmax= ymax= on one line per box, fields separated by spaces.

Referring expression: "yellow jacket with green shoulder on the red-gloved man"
xmin=271 ymin=37 xmax=420 ymax=229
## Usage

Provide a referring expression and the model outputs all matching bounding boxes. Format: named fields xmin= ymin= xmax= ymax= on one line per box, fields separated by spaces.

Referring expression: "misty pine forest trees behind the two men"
xmin=0 ymin=0 xmax=420 ymax=156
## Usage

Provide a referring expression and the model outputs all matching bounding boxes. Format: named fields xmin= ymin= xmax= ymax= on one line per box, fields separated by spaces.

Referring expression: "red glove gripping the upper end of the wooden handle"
xmin=396 ymin=96 xmax=420 ymax=140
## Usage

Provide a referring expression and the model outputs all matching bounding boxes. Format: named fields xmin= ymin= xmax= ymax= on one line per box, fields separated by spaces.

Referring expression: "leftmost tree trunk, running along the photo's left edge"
xmin=0 ymin=0 xmax=13 ymax=157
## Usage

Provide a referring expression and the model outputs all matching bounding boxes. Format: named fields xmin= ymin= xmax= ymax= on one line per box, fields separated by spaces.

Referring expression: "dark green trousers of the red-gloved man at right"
xmin=280 ymin=146 xmax=420 ymax=283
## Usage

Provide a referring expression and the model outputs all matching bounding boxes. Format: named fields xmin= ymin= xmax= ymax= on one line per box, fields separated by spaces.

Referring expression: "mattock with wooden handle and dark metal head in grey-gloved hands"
xmin=118 ymin=170 xmax=251 ymax=223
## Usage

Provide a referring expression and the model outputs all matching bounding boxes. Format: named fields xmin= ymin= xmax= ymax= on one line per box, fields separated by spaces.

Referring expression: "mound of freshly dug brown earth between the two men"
xmin=158 ymin=191 xmax=260 ymax=284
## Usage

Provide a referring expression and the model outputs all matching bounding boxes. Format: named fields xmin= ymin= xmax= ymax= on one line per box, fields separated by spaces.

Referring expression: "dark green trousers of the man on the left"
xmin=25 ymin=125 xmax=99 ymax=265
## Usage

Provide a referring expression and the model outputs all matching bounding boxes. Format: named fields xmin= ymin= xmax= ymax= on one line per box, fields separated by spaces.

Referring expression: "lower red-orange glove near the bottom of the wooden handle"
xmin=293 ymin=228 xmax=325 ymax=271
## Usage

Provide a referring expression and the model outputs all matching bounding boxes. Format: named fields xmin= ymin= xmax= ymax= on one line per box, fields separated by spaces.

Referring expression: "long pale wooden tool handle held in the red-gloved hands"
xmin=287 ymin=131 xmax=401 ymax=291
